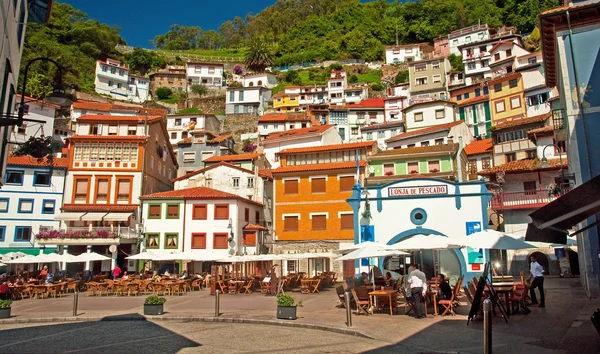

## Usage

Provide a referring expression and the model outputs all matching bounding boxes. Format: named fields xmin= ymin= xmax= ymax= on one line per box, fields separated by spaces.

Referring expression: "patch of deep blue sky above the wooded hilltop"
xmin=57 ymin=0 xmax=276 ymax=48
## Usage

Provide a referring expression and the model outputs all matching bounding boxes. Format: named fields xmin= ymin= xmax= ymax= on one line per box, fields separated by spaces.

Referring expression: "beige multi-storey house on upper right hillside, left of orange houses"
xmin=408 ymin=57 xmax=451 ymax=103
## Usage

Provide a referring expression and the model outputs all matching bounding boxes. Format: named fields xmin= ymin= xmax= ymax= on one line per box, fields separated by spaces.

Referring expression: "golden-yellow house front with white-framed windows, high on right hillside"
xmin=488 ymin=73 xmax=527 ymax=125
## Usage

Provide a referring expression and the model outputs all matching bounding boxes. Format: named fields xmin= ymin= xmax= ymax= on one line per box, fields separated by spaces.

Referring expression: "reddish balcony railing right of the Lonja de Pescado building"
xmin=490 ymin=189 xmax=569 ymax=210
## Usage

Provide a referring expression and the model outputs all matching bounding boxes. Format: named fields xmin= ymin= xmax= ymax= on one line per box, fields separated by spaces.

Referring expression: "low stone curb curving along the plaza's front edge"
xmin=0 ymin=315 xmax=375 ymax=339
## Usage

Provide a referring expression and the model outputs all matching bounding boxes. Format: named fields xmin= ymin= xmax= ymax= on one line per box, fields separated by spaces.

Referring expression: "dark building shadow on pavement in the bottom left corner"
xmin=0 ymin=313 xmax=201 ymax=354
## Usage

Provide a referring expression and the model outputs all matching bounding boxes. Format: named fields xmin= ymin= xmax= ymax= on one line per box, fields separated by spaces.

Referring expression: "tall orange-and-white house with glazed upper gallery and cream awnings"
xmin=47 ymin=115 xmax=177 ymax=273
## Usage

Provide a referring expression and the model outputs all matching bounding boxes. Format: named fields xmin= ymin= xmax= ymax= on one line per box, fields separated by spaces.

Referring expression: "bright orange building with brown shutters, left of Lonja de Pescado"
xmin=272 ymin=142 xmax=377 ymax=276
